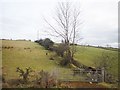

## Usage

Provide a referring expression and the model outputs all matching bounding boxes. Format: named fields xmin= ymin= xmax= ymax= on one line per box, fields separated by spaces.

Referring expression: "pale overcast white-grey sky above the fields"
xmin=0 ymin=0 xmax=119 ymax=47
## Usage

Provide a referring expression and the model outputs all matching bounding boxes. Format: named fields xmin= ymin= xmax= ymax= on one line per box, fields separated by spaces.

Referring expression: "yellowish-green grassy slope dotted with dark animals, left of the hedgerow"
xmin=2 ymin=40 xmax=71 ymax=79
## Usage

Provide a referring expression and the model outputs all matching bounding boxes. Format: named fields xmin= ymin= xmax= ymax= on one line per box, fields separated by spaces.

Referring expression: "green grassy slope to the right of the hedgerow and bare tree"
xmin=75 ymin=46 xmax=120 ymax=77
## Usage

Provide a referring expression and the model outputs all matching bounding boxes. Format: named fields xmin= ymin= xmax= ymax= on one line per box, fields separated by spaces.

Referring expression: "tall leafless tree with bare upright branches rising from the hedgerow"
xmin=45 ymin=2 xmax=81 ymax=63
